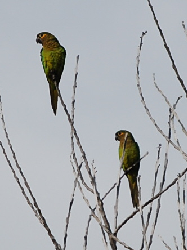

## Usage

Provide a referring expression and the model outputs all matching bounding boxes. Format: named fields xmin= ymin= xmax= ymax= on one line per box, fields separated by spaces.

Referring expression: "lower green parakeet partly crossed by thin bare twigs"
xmin=115 ymin=130 xmax=140 ymax=208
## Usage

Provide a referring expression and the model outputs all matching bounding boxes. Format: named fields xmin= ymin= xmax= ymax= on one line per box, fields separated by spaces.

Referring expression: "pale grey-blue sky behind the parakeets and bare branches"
xmin=0 ymin=0 xmax=187 ymax=250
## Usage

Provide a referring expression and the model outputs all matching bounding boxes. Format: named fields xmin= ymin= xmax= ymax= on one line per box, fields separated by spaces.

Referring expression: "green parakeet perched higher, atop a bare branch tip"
xmin=36 ymin=32 xmax=66 ymax=115
